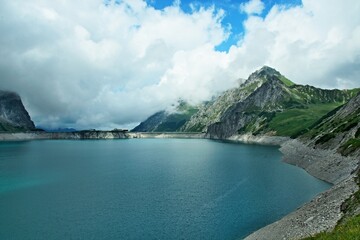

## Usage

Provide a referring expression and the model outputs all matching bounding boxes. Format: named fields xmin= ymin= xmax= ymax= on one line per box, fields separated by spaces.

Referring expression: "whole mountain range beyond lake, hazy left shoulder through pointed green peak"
xmin=134 ymin=66 xmax=360 ymax=139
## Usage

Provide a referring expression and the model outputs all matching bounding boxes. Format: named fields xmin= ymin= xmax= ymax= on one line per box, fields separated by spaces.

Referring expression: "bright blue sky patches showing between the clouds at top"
xmin=147 ymin=0 xmax=302 ymax=51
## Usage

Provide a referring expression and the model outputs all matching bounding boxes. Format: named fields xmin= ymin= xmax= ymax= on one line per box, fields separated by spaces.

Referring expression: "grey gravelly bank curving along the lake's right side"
xmin=245 ymin=139 xmax=359 ymax=240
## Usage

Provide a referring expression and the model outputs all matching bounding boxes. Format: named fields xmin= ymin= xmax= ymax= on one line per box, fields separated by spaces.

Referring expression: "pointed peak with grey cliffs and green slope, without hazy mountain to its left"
xmin=204 ymin=66 xmax=359 ymax=138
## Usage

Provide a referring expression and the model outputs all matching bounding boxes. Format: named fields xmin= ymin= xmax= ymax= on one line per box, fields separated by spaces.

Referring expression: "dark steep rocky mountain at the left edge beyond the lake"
xmin=0 ymin=90 xmax=35 ymax=132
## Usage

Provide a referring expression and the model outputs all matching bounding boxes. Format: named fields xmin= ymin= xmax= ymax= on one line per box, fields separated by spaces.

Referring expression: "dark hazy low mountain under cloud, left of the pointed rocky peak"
xmin=131 ymin=101 xmax=198 ymax=132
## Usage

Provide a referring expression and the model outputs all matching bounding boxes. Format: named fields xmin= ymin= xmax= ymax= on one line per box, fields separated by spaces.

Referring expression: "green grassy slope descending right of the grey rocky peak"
xmin=253 ymin=83 xmax=360 ymax=137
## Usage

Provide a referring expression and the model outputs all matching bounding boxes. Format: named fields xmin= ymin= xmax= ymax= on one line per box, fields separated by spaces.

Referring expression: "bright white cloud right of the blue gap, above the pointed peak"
xmin=232 ymin=0 xmax=360 ymax=88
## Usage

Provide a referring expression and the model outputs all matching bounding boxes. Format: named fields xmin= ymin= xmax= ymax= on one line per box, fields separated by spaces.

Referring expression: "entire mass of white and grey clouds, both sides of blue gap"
xmin=0 ymin=0 xmax=360 ymax=129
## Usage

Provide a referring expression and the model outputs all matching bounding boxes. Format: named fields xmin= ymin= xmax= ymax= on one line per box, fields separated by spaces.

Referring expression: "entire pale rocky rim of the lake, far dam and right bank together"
xmin=0 ymin=131 xmax=359 ymax=240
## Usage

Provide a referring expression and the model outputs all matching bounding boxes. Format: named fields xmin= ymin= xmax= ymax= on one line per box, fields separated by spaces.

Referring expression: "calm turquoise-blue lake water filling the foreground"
xmin=0 ymin=139 xmax=329 ymax=239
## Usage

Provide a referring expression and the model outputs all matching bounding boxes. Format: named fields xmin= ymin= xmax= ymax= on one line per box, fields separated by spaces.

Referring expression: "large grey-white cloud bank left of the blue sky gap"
xmin=0 ymin=0 xmax=229 ymax=128
